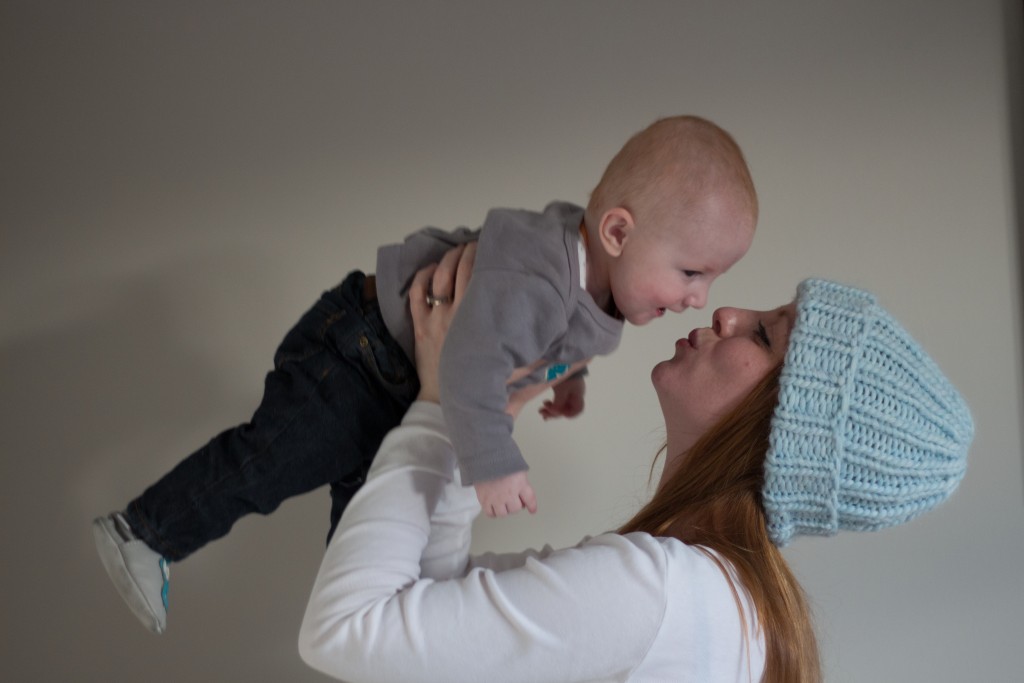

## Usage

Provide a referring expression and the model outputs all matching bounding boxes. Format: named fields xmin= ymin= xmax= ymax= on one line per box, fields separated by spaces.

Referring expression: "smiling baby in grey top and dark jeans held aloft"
xmin=93 ymin=117 xmax=758 ymax=633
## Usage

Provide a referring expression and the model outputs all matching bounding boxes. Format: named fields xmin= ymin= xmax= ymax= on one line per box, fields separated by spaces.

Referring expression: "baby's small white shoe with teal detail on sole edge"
xmin=92 ymin=512 xmax=170 ymax=633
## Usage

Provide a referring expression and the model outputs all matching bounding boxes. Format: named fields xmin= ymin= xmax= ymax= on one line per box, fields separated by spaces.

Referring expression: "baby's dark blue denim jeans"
xmin=127 ymin=272 xmax=420 ymax=561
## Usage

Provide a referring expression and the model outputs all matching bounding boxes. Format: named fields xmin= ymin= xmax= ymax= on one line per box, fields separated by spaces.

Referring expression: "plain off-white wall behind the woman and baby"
xmin=0 ymin=0 xmax=1024 ymax=682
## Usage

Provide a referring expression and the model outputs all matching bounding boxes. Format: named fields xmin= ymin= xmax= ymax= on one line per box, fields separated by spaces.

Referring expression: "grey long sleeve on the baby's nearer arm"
xmin=440 ymin=268 xmax=568 ymax=484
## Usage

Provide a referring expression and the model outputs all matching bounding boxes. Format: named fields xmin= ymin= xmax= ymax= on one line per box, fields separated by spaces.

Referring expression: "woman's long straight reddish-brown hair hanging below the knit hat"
xmin=620 ymin=365 xmax=821 ymax=683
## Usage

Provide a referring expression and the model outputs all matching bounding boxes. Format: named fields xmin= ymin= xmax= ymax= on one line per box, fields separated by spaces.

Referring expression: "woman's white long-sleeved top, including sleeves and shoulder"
xmin=299 ymin=401 xmax=764 ymax=683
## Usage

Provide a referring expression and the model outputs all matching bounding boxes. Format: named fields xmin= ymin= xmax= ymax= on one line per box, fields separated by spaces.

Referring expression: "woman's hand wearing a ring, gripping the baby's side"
xmin=409 ymin=242 xmax=476 ymax=403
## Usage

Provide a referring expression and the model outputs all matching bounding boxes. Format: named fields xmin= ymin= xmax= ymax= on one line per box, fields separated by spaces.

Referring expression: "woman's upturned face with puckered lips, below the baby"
xmin=651 ymin=303 xmax=797 ymax=453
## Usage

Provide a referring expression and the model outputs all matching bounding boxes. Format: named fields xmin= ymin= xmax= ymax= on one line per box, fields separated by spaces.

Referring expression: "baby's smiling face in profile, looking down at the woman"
xmin=609 ymin=197 xmax=754 ymax=325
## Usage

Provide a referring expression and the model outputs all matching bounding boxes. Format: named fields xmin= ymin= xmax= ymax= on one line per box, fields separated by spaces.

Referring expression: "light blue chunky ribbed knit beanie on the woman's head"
xmin=763 ymin=280 xmax=974 ymax=546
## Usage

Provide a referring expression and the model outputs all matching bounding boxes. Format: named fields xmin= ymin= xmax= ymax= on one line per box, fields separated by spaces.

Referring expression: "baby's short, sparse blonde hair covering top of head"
xmin=586 ymin=116 xmax=758 ymax=232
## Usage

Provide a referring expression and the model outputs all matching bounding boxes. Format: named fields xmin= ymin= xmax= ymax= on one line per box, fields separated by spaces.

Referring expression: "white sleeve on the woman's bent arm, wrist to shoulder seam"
xmin=299 ymin=403 xmax=667 ymax=683
